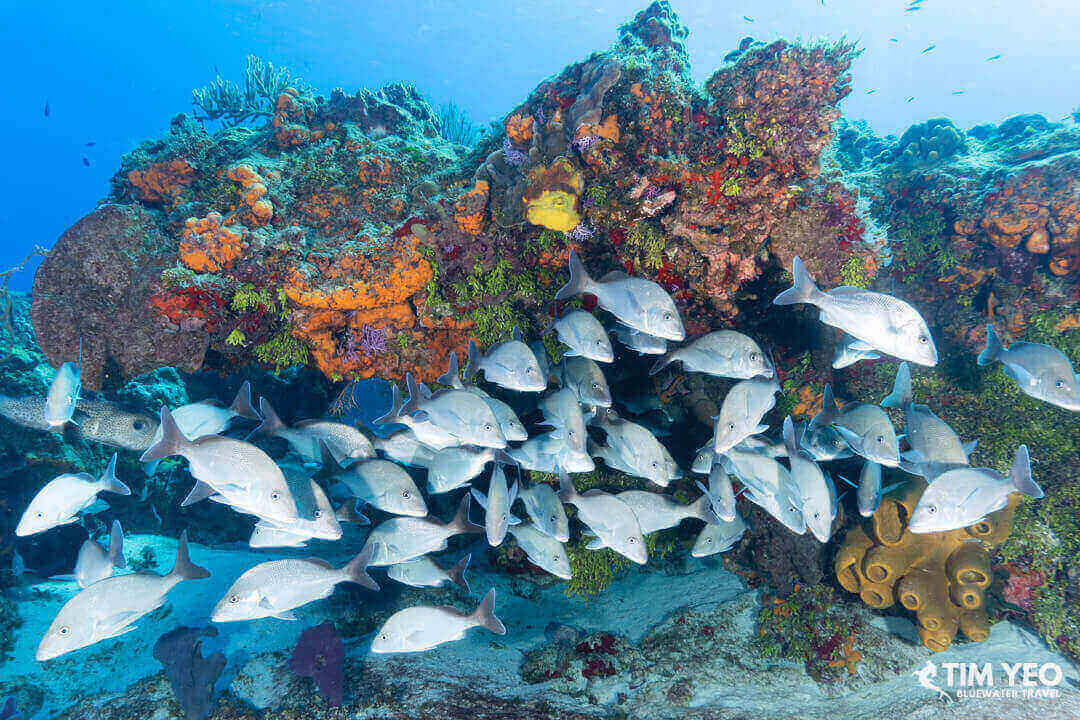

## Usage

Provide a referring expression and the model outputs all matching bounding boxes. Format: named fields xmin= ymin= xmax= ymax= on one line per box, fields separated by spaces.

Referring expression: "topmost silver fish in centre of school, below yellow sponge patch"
xmin=555 ymin=250 xmax=686 ymax=341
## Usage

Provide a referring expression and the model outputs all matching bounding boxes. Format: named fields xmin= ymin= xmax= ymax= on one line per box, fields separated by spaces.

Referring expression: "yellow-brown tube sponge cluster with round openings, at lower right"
xmin=835 ymin=480 xmax=1018 ymax=652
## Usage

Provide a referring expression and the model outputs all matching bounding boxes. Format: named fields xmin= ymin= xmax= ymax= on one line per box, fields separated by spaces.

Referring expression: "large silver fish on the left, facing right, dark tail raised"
xmin=139 ymin=407 xmax=299 ymax=525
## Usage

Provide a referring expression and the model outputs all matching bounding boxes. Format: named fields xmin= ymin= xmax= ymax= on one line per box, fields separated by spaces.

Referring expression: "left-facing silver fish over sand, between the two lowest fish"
xmin=210 ymin=545 xmax=379 ymax=623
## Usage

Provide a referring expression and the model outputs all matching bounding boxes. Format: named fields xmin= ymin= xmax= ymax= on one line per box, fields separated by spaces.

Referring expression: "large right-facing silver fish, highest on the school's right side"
xmin=772 ymin=257 xmax=937 ymax=367
